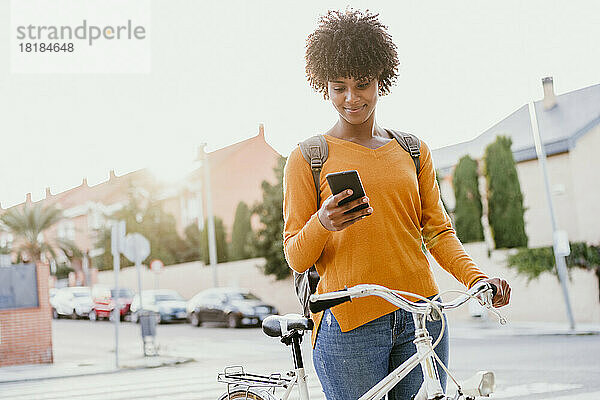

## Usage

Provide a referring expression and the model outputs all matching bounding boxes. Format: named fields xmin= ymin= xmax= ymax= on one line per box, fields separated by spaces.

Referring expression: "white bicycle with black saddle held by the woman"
xmin=217 ymin=282 xmax=506 ymax=400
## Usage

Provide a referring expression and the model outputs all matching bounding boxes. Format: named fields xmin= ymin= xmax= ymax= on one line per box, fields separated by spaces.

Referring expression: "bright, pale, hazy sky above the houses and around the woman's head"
xmin=0 ymin=0 xmax=600 ymax=208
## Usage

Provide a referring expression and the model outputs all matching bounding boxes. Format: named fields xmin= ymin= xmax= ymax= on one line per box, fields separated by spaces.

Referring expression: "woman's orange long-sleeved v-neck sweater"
xmin=283 ymin=135 xmax=487 ymax=345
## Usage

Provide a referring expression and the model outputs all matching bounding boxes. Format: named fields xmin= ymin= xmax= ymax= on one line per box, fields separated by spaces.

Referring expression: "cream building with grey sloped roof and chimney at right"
xmin=433 ymin=78 xmax=600 ymax=247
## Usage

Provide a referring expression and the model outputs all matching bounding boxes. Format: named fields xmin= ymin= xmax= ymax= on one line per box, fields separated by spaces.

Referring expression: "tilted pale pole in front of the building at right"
xmin=529 ymin=102 xmax=575 ymax=330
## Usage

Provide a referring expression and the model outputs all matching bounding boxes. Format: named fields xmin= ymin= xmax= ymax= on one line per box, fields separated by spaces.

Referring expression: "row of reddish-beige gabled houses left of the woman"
xmin=0 ymin=124 xmax=280 ymax=268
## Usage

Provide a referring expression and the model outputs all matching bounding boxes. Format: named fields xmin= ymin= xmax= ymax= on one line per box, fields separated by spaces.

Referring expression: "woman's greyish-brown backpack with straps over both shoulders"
xmin=294 ymin=130 xmax=421 ymax=317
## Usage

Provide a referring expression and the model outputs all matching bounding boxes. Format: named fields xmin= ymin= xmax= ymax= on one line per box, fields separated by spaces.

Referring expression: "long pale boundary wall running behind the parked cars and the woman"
xmin=98 ymin=247 xmax=600 ymax=323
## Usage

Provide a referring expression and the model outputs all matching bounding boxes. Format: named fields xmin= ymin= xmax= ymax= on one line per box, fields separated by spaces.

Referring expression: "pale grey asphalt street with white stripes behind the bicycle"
xmin=0 ymin=320 xmax=600 ymax=400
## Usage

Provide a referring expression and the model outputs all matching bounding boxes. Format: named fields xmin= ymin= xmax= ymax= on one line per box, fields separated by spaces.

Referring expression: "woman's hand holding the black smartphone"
xmin=318 ymin=189 xmax=373 ymax=231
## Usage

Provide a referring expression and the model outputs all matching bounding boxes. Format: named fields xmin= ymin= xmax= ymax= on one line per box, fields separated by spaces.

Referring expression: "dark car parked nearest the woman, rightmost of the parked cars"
xmin=186 ymin=288 xmax=278 ymax=328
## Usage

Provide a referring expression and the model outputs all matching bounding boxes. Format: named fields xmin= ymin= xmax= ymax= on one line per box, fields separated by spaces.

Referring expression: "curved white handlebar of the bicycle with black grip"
xmin=309 ymin=282 xmax=496 ymax=314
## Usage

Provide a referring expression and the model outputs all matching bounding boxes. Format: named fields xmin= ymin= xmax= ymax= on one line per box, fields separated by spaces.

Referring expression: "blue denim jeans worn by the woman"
xmin=313 ymin=309 xmax=448 ymax=400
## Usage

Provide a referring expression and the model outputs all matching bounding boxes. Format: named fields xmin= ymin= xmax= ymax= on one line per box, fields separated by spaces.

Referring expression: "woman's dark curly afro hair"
xmin=305 ymin=9 xmax=399 ymax=99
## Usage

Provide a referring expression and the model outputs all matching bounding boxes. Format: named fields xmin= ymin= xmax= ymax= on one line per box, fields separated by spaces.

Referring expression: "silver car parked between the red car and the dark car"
xmin=130 ymin=289 xmax=187 ymax=324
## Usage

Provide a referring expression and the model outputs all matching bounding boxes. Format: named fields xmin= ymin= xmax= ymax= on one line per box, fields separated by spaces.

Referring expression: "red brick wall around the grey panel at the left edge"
xmin=0 ymin=264 xmax=53 ymax=367
